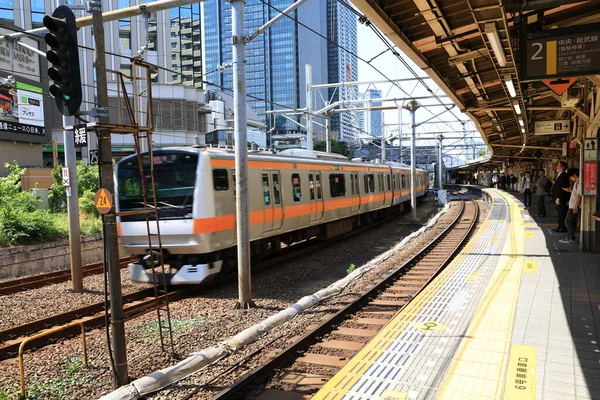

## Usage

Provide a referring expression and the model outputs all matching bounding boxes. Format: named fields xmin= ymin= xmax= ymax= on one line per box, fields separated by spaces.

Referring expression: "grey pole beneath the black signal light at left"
xmin=63 ymin=117 xmax=83 ymax=292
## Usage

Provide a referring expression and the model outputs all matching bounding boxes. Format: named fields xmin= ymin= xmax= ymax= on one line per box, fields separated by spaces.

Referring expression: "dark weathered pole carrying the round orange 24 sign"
xmin=90 ymin=0 xmax=127 ymax=387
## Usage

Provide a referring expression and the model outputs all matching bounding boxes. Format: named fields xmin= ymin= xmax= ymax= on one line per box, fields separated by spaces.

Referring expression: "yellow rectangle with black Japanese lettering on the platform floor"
xmin=504 ymin=344 xmax=537 ymax=400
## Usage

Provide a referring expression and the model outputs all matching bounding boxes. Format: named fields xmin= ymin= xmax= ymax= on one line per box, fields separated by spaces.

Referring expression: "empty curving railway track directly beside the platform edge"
xmin=211 ymin=200 xmax=479 ymax=400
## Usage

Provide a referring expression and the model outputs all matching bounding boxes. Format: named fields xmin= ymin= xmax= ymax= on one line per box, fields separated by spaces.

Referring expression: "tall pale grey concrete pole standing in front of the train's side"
xmin=229 ymin=0 xmax=254 ymax=309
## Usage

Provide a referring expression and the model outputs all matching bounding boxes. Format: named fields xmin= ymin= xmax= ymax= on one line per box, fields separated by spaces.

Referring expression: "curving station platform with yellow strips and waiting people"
xmin=313 ymin=189 xmax=600 ymax=400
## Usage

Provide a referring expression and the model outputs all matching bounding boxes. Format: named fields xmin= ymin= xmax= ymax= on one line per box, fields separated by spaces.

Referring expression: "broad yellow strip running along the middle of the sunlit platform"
xmin=436 ymin=191 xmax=524 ymax=399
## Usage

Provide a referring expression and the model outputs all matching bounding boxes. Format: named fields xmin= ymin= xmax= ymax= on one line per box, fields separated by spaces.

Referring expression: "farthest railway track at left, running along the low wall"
xmin=0 ymin=257 xmax=137 ymax=296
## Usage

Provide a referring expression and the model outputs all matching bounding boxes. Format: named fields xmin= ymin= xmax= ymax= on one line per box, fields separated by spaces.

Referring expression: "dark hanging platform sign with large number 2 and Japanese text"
xmin=520 ymin=23 xmax=600 ymax=81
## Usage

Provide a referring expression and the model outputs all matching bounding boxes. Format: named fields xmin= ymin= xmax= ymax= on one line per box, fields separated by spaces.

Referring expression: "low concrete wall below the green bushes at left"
xmin=0 ymin=234 xmax=128 ymax=279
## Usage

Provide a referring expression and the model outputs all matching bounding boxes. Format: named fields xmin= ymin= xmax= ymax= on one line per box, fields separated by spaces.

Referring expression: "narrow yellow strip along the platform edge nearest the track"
xmin=312 ymin=205 xmax=498 ymax=400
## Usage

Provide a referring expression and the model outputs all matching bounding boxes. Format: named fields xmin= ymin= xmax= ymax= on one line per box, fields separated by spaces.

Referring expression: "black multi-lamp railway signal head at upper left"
xmin=42 ymin=5 xmax=82 ymax=116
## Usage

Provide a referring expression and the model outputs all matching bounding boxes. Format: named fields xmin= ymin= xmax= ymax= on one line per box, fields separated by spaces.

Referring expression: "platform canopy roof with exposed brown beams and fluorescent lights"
xmin=353 ymin=0 xmax=600 ymax=159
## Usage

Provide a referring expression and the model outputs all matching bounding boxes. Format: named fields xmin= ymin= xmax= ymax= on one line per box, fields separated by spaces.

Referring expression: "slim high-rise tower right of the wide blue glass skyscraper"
xmin=327 ymin=0 xmax=359 ymax=143
